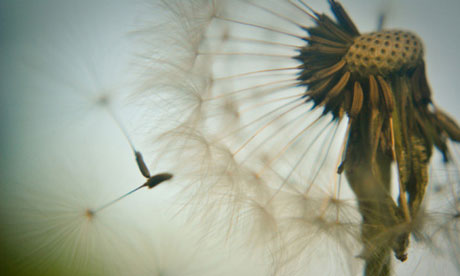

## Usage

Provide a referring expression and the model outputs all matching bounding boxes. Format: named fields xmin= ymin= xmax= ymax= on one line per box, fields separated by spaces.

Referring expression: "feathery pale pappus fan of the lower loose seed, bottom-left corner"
xmin=1 ymin=171 xmax=142 ymax=275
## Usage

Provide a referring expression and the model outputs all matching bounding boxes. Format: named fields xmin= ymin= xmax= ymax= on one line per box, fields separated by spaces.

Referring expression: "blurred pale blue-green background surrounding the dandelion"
xmin=0 ymin=0 xmax=460 ymax=275
